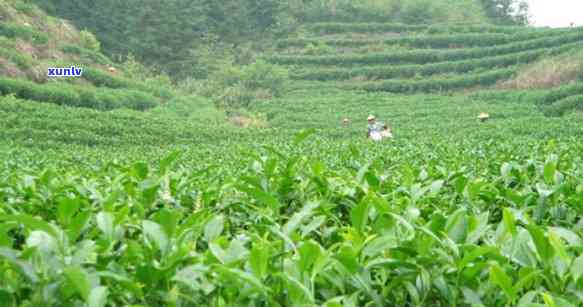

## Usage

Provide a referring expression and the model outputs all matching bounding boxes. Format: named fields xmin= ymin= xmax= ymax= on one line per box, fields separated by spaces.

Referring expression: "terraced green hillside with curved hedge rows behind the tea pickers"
xmin=266 ymin=23 xmax=583 ymax=93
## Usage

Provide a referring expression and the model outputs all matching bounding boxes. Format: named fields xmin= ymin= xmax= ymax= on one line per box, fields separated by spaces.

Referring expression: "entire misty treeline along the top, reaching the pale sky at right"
xmin=33 ymin=0 xmax=528 ymax=78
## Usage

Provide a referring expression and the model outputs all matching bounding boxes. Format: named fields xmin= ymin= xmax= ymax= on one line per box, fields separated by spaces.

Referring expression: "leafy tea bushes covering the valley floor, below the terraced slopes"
xmin=0 ymin=92 xmax=583 ymax=306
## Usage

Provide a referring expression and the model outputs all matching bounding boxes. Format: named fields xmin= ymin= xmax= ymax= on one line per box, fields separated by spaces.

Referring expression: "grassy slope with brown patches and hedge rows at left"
xmin=0 ymin=1 xmax=178 ymax=110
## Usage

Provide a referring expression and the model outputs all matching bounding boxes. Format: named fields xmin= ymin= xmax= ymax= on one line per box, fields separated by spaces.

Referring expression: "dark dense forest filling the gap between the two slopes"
xmin=37 ymin=0 xmax=284 ymax=78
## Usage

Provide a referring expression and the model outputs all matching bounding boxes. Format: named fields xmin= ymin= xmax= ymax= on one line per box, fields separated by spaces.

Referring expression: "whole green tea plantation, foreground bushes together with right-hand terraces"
xmin=0 ymin=12 xmax=583 ymax=307
